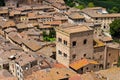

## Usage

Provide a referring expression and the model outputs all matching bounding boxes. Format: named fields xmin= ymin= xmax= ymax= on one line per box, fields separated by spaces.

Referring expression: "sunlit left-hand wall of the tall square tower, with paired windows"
xmin=56 ymin=29 xmax=70 ymax=66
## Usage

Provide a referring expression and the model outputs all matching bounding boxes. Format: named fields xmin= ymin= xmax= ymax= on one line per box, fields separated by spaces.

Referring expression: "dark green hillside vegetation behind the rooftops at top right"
xmin=65 ymin=0 xmax=120 ymax=13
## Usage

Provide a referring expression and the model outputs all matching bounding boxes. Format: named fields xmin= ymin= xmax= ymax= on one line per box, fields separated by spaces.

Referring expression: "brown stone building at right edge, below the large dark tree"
xmin=104 ymin=43 xmax=120 ymax=68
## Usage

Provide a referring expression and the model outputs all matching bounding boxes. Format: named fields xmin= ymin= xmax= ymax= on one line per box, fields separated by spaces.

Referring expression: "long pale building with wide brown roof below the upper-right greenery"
xmin=82 ymin=7 xmax=120 ymax=30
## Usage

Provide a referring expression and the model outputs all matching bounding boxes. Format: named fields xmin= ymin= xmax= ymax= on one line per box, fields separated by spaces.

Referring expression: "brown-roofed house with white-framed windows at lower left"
xmin=9 ymin=53 xmax=37 ymax=80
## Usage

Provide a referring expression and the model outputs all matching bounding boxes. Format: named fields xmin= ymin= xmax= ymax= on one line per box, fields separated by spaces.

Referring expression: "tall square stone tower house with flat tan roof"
xmin=56 ymin=24 xmax=93 ymax=67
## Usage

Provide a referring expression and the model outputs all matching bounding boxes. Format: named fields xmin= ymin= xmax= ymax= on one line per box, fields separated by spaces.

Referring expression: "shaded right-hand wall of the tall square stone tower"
xmin=70 ymin=30 xmax=93 ymax=61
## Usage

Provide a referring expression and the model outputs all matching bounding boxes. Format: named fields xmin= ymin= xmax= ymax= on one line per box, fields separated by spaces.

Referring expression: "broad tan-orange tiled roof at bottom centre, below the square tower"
xmin=25 ymin=68 xmax=77 ymax=80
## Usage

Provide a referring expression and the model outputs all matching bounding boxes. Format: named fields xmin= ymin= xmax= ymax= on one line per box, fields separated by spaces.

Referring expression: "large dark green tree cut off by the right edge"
xmin=110 ymin=19 xmax=120 ymax=42
